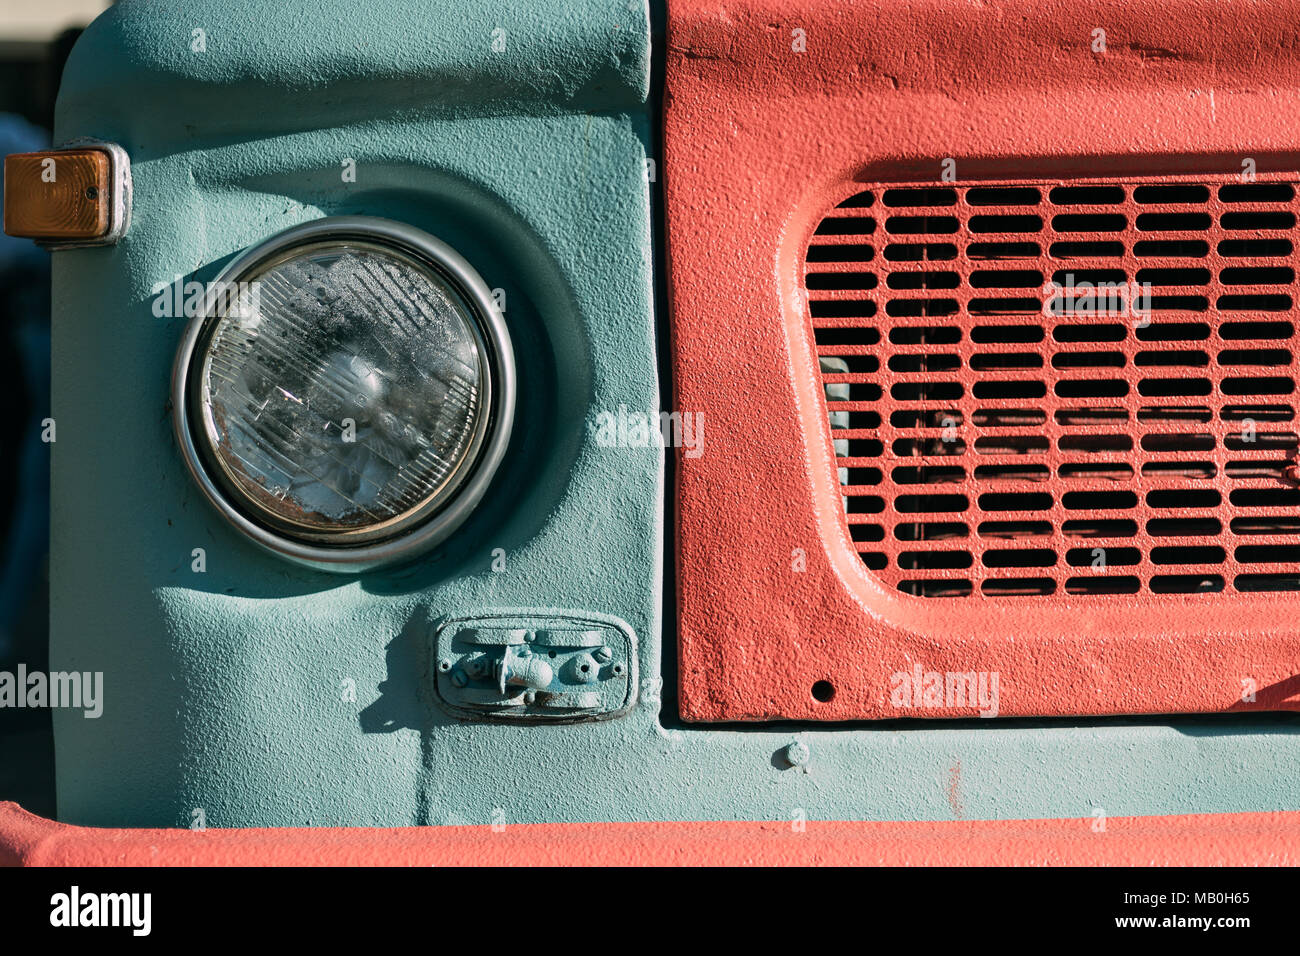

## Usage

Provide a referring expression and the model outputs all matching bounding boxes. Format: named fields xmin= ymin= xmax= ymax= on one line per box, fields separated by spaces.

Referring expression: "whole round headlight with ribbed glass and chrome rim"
xmin=173 ymin=217 xmax=515 ymax=570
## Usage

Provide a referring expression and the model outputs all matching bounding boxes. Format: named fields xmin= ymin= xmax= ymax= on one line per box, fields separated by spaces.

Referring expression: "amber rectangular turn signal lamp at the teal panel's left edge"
xmin=4 ymin=144 xmax=126 ymax=246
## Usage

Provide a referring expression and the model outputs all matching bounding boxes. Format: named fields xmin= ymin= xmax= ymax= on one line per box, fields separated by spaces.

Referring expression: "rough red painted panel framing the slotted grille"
xmin=664 ymin=0 xmax=1300 ymax=717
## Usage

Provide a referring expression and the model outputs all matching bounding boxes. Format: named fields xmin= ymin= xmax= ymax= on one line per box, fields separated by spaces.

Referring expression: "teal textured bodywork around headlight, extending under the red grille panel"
xmin=51 ymin=0 xmax=1300 ymax=827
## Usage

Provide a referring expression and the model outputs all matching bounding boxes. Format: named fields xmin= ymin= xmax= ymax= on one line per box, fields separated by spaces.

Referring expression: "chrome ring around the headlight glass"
xmin=172 ymin=216 xmax=515 ymax=572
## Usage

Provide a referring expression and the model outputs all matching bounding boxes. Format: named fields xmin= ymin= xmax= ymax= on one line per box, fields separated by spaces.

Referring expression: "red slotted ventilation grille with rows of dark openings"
xmin=803 ymin=179 xmax=1300 ymax=601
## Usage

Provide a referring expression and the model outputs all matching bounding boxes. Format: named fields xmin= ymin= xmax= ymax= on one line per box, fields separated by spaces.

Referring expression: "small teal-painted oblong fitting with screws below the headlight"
xmin=433 ymin=615 xmax=637 ymax=721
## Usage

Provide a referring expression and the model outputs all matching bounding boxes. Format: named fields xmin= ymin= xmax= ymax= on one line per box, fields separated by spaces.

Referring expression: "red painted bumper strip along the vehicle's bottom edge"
xmin=0 ymin=803 xmax=1300 ymax=866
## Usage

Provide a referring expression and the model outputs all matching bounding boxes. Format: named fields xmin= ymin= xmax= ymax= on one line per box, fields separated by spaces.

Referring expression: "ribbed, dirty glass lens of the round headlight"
xmin=192 ymin=239 xmax=491 ymax=545
